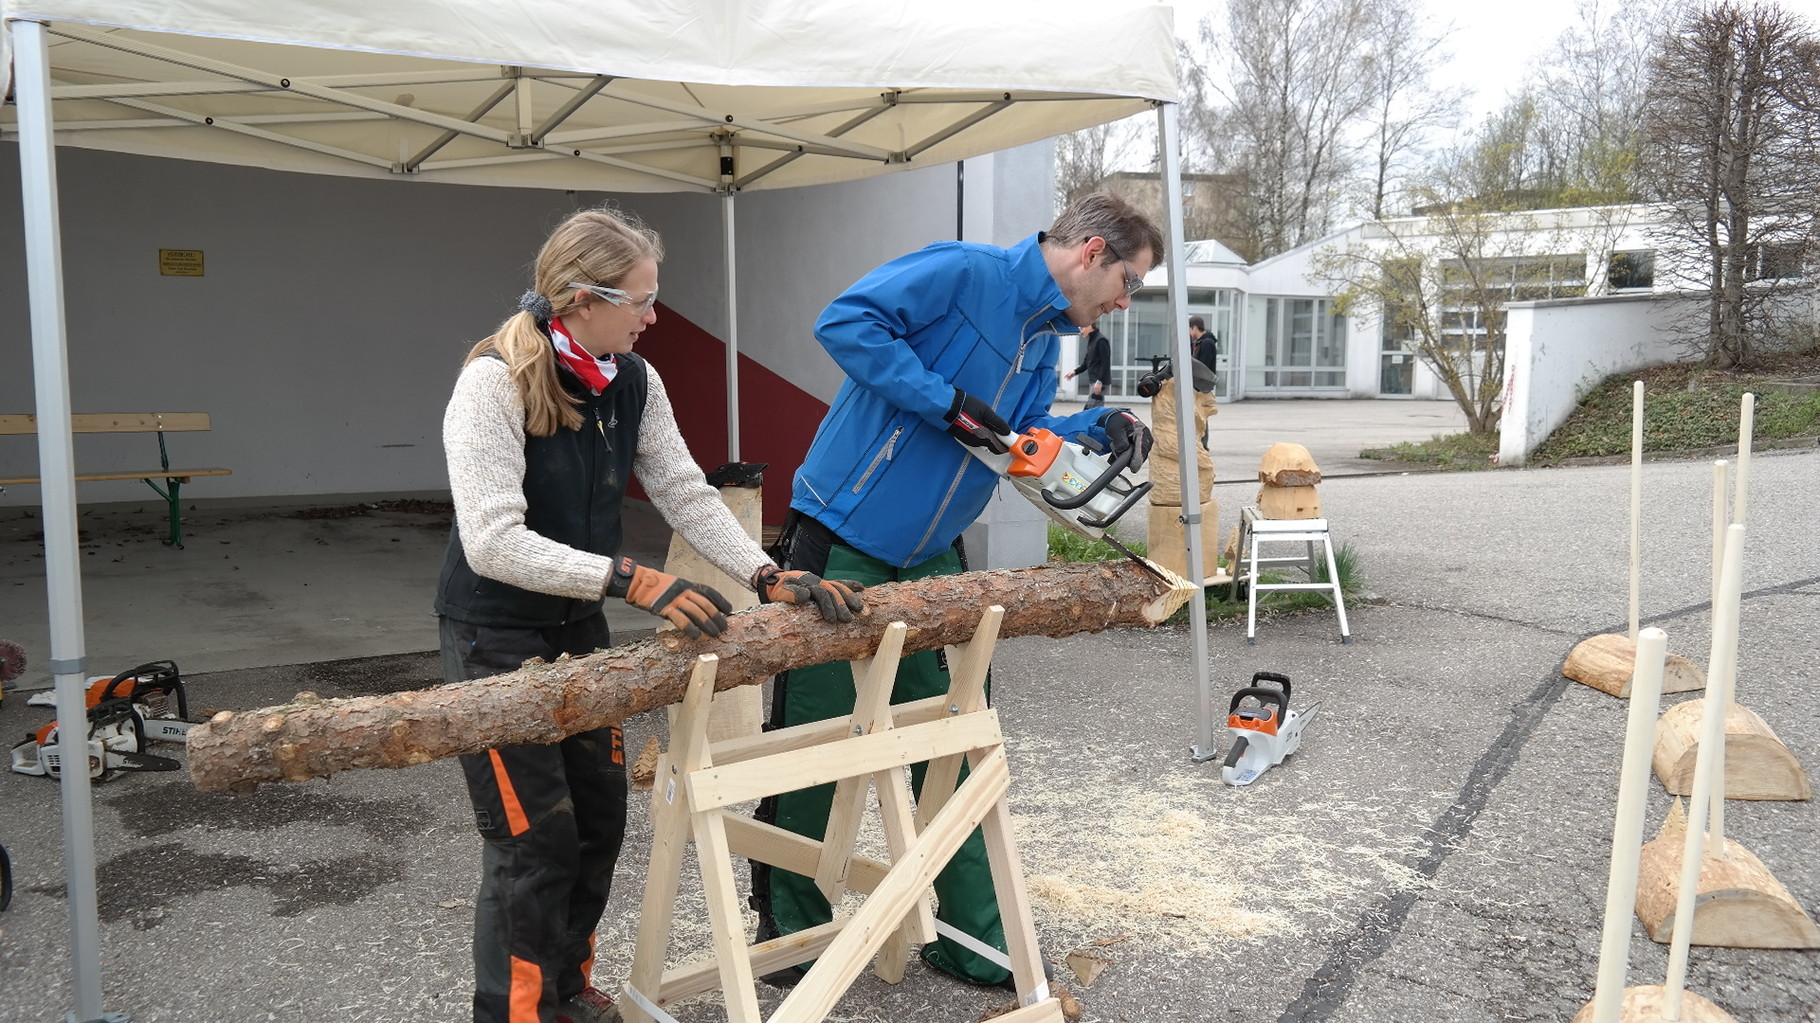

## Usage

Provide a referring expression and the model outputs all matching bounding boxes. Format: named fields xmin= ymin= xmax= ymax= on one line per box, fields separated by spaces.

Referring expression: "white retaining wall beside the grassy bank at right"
xmin=1498 ymin=295 xmax=1700 ymax=466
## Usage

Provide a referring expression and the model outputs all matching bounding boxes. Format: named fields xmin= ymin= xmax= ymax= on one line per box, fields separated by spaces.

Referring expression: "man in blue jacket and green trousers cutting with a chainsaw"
xmin=752 ymin=193 xmax=1163 ymax=985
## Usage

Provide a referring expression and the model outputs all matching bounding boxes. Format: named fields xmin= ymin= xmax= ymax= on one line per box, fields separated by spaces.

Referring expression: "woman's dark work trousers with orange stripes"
xmin=442 ymin=615 xmax=626 ymax=1023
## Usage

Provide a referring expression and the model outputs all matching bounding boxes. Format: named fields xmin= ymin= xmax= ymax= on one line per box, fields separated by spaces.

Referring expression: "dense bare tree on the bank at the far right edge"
xmin=1643 ymin=0 xmax=1820 ymax=368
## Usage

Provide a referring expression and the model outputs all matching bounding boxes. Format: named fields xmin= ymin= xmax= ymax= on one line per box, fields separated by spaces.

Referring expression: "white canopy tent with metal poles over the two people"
xmin=0 ymin=0 xmax=1212 ymax=1021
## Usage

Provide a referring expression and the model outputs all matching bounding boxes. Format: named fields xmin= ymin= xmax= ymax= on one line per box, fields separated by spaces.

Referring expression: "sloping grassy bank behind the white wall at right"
xmin=1531 ymin=366 xmax=1820 ymax=466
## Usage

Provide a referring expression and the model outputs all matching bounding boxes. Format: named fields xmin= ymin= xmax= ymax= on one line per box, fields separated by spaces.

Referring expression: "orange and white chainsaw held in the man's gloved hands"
xmin=968 ymin=428 xmax=1168 ymax=582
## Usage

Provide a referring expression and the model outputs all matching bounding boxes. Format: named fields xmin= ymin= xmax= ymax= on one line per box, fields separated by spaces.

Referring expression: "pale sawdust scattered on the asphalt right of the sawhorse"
xmin=1010 ymin=739 xmax=1427 ymax=956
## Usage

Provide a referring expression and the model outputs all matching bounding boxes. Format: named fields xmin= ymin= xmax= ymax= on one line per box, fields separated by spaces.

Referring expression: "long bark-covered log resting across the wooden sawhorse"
xmin=187 ymin=561 xmax=1194 ymax=794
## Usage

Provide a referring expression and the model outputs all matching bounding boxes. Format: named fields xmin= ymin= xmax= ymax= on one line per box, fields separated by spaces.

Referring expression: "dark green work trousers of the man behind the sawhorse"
xmin=752 ymin=544 xmax=1010 ymax=985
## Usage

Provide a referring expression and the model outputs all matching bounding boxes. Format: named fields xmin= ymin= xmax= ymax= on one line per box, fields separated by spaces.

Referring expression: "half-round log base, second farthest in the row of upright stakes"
xmin=1654 ymin=699 xmax=1815 ymax=799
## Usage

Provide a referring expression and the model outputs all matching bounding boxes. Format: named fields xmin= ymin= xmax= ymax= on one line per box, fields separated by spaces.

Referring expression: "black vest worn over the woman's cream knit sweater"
xmin=437 ymin=353 xmax=646 ymax=628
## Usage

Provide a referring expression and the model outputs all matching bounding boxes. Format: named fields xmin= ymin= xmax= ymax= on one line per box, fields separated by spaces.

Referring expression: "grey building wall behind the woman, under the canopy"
xmin=0 ymin=144 xmax=1052 ymax=506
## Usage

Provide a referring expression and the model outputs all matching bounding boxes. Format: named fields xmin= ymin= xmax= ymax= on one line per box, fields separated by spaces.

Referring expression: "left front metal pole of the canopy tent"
xmin=11 ymin=22 xmax=126 ymax=1023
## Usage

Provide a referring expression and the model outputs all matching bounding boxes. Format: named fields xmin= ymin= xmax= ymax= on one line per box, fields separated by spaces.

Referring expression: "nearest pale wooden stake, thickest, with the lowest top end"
xmin=1593 ymin=629 xmax=1669 ymax=1023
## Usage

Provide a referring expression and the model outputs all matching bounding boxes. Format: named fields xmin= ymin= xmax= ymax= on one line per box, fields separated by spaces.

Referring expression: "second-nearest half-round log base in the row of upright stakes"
xmin=1636 ymin=806 xmax=1820 ymax=948
